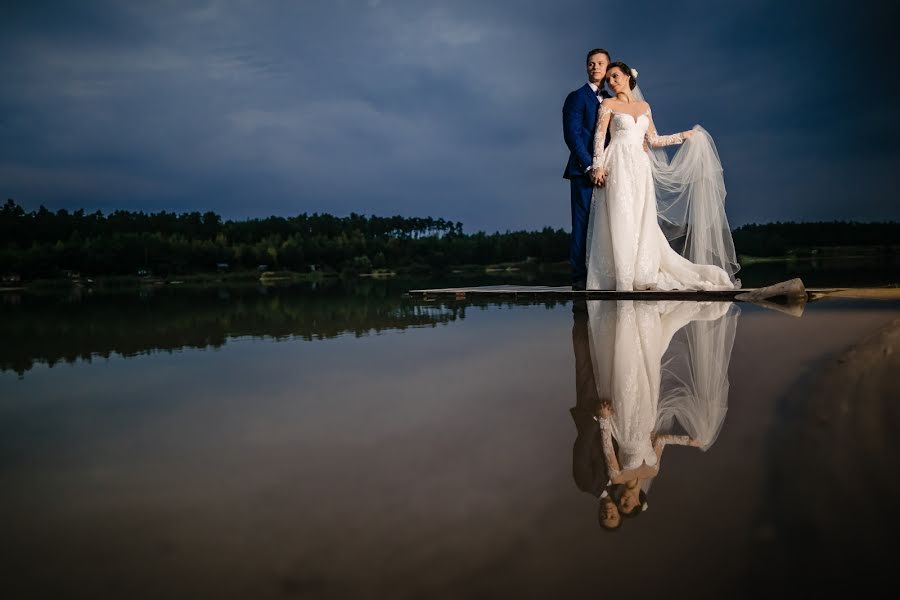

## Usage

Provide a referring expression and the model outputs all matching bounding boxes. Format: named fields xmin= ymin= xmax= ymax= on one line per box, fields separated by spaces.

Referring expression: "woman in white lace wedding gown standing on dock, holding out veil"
xmin=587 ymin=62 xmax=740 ymax=291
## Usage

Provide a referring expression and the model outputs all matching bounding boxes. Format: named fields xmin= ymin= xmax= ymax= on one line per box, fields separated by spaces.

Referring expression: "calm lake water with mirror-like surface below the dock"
xmin=0 ymin=265 xmax=900 ymax=599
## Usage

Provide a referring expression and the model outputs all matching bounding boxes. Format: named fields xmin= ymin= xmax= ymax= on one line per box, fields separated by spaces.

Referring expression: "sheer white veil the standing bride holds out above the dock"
xmin=632 ymin=86 xmax=740 ymax=287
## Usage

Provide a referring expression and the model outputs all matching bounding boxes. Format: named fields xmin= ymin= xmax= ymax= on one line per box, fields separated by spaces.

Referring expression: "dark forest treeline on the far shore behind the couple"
xmin=0 ymin=200 xmax=900 ymax=279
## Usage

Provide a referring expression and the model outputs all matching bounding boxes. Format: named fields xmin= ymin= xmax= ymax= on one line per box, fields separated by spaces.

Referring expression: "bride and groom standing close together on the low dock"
xmin=563 ymin=48 xmax=740 ymax=291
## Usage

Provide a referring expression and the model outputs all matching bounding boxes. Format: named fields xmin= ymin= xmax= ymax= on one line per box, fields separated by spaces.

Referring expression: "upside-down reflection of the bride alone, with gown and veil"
xmin=588 ymin=300 xmax=740 ymax=515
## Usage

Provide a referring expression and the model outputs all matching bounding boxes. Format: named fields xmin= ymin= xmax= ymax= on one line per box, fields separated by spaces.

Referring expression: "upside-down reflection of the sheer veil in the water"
xmin=657 ymin=303 xmax=740 ymax=450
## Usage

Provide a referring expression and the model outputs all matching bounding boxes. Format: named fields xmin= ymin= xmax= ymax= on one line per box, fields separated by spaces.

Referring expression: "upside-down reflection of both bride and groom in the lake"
xmin=571 ymin=300 xmax=740 ymax=530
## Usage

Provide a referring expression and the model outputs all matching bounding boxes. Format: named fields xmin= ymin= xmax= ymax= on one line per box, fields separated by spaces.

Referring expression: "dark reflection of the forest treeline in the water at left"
xmin=0 ymin=286 xmax=465 ymax=374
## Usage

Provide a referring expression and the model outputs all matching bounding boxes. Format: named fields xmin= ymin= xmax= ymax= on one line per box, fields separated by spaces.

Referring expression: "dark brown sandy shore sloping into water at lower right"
xmin=755 ymin=319 xmax=900 ymax=584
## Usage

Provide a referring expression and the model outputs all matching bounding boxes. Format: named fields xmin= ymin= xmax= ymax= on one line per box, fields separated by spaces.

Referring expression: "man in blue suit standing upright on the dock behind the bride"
xmin=563 ymin=48 xmax=610 ymax=290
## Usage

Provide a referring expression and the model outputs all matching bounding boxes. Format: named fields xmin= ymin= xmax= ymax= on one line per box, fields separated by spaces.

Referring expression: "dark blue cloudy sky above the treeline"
xmin=0 ymin=0 xmax=900 ymax=232
